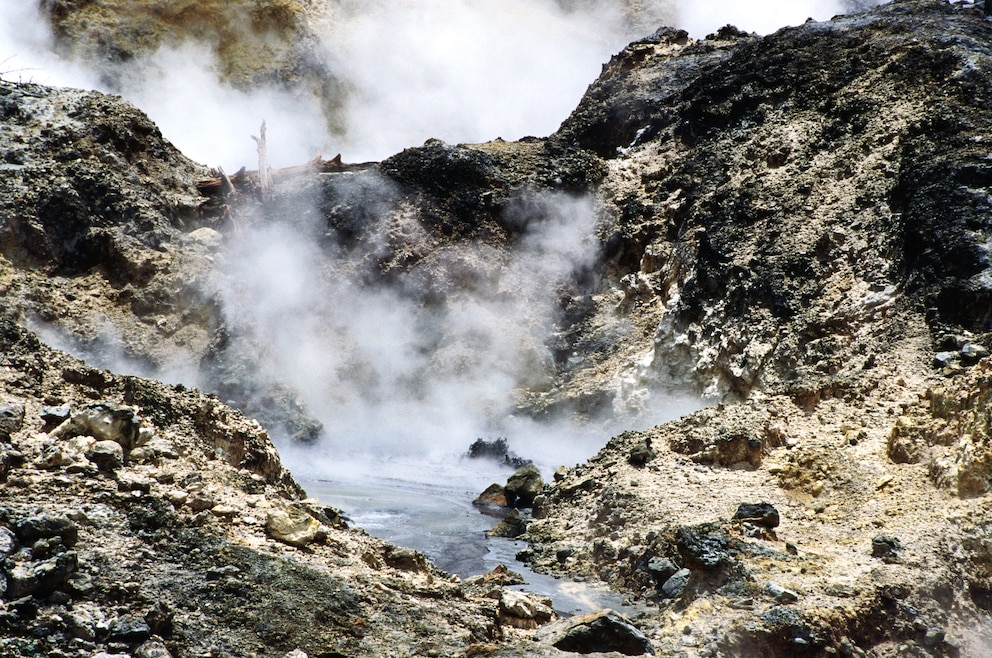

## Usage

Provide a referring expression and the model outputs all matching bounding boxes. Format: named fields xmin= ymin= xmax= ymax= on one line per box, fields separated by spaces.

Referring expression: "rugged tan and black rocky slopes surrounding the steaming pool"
xmin=0 ymin=0 xmax=992 ymax=656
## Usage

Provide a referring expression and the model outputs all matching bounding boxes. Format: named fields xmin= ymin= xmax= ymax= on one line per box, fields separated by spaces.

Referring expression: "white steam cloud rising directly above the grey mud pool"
xmin=209 ymin=175 xmax=616 ymax=468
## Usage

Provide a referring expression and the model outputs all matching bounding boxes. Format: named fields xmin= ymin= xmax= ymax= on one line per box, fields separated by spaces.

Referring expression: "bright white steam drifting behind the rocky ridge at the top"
xmin=0 ymin=0 xmax=884 ymax=171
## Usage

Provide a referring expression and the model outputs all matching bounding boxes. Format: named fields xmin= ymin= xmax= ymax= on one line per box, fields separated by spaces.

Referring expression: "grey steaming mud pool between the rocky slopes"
xmin=297 ymin=458 xmax=631 ymax=616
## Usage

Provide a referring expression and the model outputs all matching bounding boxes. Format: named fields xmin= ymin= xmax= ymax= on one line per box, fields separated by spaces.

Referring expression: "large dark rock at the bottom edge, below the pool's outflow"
xmin=537 ymin=610 xmax=655 ymax=656
